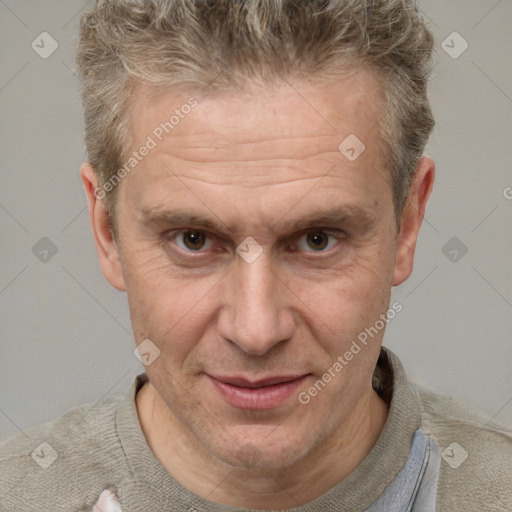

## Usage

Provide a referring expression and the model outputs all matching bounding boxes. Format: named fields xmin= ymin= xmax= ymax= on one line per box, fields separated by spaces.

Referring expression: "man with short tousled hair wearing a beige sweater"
xmin=0 ymin=0 xmax=512 ymax=512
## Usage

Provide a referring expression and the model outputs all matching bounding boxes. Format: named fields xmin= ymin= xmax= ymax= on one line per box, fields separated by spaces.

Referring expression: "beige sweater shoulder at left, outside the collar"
xmin=0 ymin=398 xmax=121 ymax=512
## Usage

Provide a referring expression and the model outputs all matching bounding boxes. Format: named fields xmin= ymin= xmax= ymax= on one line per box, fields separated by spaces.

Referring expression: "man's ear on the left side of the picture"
xmin=80 ymin=163 xmax=126 ymax=291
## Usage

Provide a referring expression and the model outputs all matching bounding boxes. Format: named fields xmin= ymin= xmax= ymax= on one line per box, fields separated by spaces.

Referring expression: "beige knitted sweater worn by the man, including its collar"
xmin=0 ymin=348 xmax=512 ymax=512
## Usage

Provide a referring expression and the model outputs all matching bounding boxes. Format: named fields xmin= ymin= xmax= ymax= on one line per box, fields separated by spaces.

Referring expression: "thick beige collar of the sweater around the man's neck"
xmin=116 ymin=347 xmax=420 ymax=512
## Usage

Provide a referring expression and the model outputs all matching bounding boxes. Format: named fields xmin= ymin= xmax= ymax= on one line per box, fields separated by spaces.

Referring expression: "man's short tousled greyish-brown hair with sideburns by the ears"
xmin=77 ymin=0 xmax=434 ymax=232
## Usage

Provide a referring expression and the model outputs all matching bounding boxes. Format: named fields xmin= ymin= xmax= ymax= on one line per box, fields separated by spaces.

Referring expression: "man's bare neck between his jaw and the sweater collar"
xmin=136 ymin=382 xmax=388 ymax=509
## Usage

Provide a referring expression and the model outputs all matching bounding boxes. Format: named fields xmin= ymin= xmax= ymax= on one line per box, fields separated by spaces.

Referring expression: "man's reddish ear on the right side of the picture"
xmin=393 ymin=156 xmax=435 ymax=286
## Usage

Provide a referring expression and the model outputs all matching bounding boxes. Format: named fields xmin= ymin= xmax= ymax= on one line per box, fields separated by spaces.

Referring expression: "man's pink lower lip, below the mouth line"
xmin=210 ymin=375 xmax=308 ymax=410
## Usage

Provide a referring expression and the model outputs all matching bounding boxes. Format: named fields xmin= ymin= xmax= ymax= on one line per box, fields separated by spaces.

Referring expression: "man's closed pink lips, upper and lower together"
xmin=208 ymin=374 xmax=309 ymax=410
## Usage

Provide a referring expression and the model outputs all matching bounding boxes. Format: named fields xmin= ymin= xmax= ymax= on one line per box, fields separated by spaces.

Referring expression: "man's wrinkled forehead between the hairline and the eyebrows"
xmin=122 ymin=71 xmax=392 ymax=228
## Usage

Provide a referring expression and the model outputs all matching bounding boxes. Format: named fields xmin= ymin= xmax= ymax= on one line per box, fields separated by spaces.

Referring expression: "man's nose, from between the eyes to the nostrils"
xmin=218 ymin=251 xmax=295 ymax=355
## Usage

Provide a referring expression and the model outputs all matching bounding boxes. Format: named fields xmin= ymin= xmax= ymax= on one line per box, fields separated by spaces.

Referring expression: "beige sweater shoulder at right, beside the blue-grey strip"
xmin=410 ymin=384 xmax=512 ymax=511
